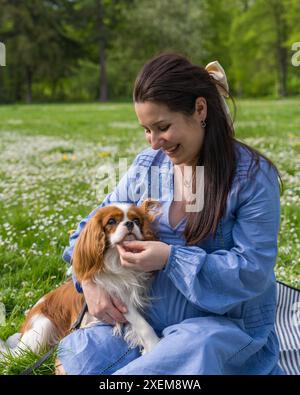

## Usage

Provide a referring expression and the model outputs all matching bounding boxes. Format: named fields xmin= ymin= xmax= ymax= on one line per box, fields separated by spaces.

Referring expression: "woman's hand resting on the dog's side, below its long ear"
xmin=81 ymin=280 xmax=127 ymax=325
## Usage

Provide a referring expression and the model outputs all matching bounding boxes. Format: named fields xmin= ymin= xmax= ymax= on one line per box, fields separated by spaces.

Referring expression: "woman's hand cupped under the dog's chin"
xmin=117 ymin=240 xmax=171 ymax=272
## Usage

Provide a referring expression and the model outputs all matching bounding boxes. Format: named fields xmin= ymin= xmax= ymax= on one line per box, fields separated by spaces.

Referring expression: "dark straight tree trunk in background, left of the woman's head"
xmin=97 ymin=0 xmax=108 ymax=102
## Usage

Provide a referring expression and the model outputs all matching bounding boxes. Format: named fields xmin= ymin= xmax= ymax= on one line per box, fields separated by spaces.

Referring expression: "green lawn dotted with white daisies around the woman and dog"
xmin=0 ymin=99 xmax=300 ymax=374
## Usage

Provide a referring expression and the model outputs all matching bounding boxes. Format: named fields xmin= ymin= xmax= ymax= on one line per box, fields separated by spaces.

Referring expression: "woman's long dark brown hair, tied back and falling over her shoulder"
xmin=133 ymin=53 xmax=280 ymax=244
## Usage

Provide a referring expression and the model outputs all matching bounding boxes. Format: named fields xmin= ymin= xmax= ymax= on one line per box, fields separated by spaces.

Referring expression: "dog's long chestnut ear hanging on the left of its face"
xmin=72 ymin=214 xmax=105 ymax=281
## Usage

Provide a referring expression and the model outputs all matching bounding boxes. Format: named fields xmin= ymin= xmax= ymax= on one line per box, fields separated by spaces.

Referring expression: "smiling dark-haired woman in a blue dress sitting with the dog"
xmin=59 ymin=53 xmax=282 ymax=374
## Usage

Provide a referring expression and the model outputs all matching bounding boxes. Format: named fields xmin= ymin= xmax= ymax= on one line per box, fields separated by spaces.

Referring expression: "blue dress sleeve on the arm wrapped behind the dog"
xmin=62 ymin=153 xmax=146 ymax=293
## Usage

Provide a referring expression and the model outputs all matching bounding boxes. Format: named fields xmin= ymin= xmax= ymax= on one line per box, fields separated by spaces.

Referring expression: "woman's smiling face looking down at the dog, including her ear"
xmin=135 ymin=97 xmax=206 ymax=166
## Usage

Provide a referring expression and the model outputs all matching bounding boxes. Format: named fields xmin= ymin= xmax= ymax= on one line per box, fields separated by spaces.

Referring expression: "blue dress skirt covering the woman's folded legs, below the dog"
xmin=58 ymin=316 xmax=278 ymax=375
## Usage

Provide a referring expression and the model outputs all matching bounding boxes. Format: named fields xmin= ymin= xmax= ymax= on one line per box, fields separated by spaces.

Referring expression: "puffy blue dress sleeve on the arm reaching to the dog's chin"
xmin=164 ymin=164 xmax=280 ymax=314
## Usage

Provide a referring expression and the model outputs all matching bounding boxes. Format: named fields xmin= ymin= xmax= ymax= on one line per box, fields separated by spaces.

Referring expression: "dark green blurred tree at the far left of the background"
xmin=0 ymin=0 xmax=78 ymax=103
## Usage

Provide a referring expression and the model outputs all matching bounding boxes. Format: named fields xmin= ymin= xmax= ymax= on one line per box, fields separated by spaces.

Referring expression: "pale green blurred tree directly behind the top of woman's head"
xmin=108 ymin=0 xmax=208 ymax=98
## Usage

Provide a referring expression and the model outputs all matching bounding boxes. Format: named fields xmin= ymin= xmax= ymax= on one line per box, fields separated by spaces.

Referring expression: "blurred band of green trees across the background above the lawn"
xmin=0 ymin=0 xmax=300 ymax=103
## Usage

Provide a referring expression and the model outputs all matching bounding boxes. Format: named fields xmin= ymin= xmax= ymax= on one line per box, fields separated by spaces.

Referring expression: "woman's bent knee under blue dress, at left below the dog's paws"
xmin=57 ymin=324 xmax=141 ymax=375
